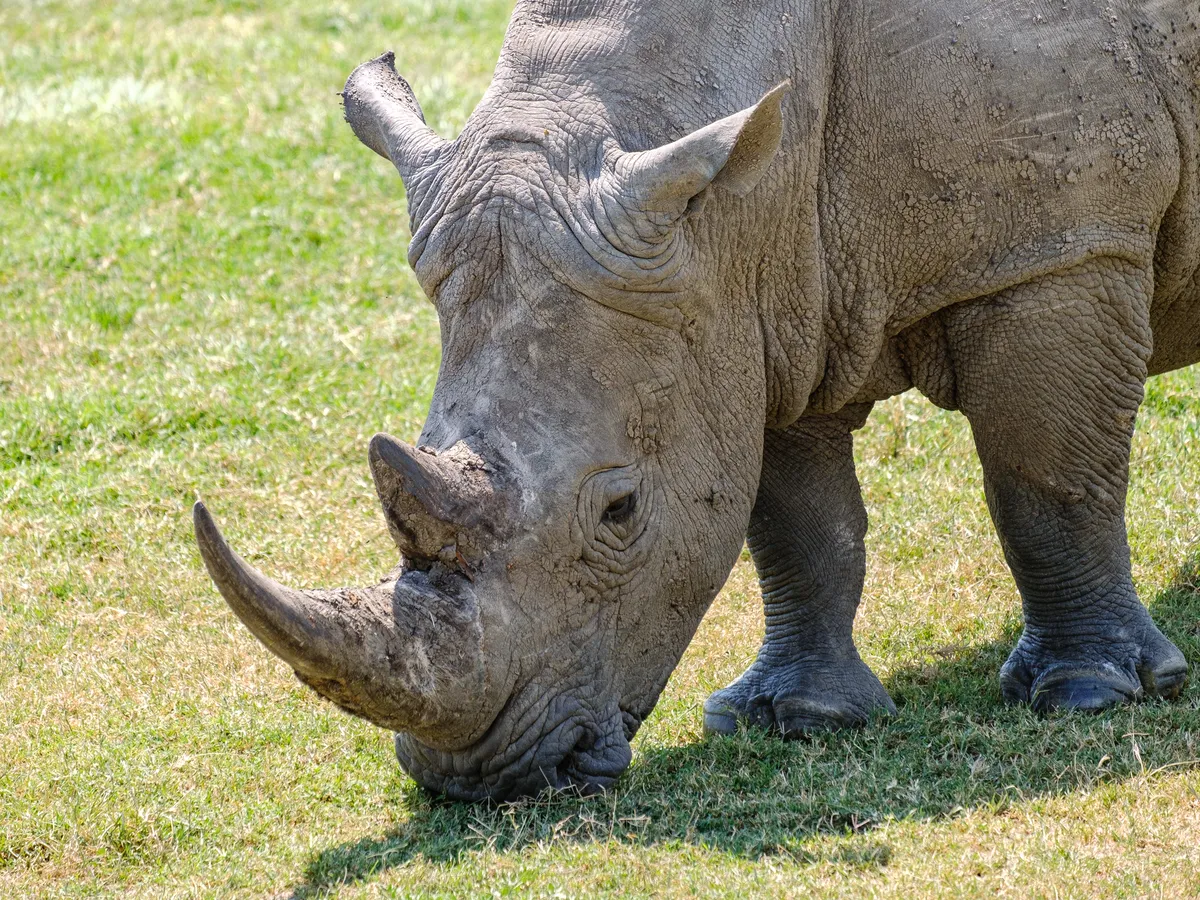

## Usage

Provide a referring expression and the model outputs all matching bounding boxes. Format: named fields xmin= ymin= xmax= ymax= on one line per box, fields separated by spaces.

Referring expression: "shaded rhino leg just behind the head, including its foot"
xmin=704 ymin=404 xmax=895 ymax=737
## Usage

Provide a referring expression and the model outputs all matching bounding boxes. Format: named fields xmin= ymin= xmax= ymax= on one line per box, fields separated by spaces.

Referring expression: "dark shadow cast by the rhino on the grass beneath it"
xmin=294 ymin=553 xmax=1200 ymax=899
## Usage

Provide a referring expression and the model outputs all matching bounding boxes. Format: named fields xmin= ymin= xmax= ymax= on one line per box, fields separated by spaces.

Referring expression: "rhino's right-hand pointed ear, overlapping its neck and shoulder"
xmin=616 ymin=82 xmax=792 ymax=220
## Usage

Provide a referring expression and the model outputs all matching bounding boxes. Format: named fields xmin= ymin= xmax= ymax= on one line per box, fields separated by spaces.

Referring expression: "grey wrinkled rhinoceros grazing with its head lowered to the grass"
xmin=196 ymin=0 xmax=1200 ymax=799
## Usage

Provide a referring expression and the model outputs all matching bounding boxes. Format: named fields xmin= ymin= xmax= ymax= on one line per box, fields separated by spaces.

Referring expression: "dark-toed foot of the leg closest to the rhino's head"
xmin=704 ymin=654 xmax=895 ymax=738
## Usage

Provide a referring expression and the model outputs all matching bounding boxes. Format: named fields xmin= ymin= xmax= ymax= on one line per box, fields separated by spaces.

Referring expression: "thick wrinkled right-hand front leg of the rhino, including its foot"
xmin=948 ymin=259 xmax=1187 ymax=712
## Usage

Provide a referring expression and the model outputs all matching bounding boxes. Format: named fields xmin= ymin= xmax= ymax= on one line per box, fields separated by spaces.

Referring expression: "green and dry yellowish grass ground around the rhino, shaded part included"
xmin=0 ymin=0 xmax=1200 ymax=898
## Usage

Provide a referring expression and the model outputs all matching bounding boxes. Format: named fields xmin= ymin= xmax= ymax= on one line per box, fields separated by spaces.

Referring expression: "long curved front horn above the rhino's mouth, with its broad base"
xmin=193 ymin=503 xmax=504 ymax=750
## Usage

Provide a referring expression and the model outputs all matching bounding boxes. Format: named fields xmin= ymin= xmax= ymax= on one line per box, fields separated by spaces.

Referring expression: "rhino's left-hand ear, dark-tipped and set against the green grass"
xmin=342 ymin=50 xmax=449 ymax=205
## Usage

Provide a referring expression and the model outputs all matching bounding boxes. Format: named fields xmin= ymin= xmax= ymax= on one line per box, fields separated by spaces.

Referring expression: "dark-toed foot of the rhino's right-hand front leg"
xmin=1000 ymin=614 xmax=1188 ymax=713
